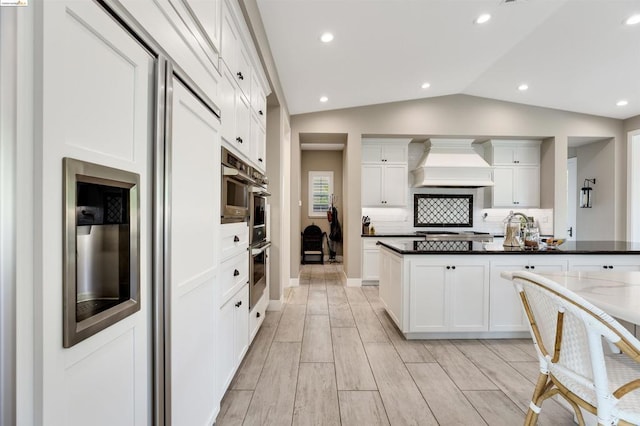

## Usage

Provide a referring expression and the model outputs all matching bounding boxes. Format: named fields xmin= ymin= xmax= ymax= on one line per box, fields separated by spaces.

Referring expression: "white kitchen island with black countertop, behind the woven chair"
xmin=379 ymin=240 xmax=640 ymax=339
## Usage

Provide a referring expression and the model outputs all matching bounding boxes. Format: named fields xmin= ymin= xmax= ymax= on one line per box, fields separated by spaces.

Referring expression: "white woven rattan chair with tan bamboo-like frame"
xmin=512 ymin=271 xmax=640 ymax=425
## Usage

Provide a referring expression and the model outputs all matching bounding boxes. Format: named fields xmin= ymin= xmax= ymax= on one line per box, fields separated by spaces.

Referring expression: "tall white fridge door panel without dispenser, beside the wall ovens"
xmin=168 ymin=79 xmax=220 ymax=424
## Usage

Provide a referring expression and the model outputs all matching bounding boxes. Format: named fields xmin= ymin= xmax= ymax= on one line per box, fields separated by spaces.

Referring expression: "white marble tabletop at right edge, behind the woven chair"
xmin=500 ymin=271 xmax=640 ymax=325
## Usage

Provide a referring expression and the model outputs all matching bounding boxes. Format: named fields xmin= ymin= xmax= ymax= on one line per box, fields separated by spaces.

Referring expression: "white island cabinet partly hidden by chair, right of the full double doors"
xmin=489 ymin=255 xmax=567 ymax=331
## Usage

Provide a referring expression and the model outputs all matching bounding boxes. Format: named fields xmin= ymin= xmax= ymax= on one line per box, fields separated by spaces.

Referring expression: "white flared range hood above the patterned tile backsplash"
xmin=411 ymin=139 xmax=493 ymax=188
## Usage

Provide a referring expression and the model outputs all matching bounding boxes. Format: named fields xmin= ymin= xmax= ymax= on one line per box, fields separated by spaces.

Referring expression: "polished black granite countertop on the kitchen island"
xmin=378 ymin=240 xmax=640 ymax=255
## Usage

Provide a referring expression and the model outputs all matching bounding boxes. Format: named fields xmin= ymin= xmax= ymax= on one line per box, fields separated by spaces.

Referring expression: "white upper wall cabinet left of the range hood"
xmin=362 ymin=139 xmax=410 ymax=207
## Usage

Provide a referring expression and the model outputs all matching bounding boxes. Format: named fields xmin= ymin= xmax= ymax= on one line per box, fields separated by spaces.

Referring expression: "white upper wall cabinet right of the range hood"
xmin=485 ymin=141 xmax=540 ymax=207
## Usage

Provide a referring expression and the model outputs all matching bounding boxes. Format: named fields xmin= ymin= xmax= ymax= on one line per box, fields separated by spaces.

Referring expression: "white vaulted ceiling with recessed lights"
xmin=257 ymin=0 xmax=640 ymax=119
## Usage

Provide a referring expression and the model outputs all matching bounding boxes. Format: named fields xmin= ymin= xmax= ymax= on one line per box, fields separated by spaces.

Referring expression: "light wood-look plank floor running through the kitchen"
xmin=216 ymin=264 xmax=574 ymax=426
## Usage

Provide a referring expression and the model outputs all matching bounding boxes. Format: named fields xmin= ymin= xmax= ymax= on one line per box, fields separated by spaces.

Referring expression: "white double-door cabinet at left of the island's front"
xmin=409 ymin=256 xmax=489 ymax=333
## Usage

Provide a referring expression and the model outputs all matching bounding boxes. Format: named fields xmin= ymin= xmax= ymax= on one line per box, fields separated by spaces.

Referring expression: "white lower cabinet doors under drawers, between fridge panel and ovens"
xmin=217 ymin=284 xmax=249 ymax=397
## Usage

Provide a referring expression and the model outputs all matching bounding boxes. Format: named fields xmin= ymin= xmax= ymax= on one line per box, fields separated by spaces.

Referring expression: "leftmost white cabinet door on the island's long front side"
xmin=409 ymin=261 xmax=449 ymax=333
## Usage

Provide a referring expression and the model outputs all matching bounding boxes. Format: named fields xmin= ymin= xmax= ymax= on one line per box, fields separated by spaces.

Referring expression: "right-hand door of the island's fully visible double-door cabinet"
xmin=446 ymin=259 xmax=489 ymax=331
